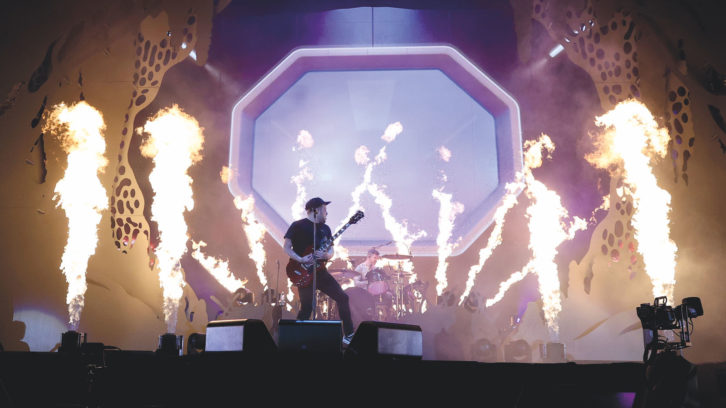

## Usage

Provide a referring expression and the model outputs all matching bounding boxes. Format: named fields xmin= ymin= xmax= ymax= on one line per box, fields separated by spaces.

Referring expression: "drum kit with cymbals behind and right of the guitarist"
xmin=317 ymin=254 xmax=428 ymax=325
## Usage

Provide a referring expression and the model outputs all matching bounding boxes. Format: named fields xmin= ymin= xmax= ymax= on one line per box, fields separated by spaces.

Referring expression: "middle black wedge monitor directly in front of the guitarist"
xmin=278 ymin=320 xmax=343 ymax=354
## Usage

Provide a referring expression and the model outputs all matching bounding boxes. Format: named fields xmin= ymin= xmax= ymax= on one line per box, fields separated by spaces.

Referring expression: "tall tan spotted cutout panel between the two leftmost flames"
xmin=110 ymin=10 xmax=197 ymax=253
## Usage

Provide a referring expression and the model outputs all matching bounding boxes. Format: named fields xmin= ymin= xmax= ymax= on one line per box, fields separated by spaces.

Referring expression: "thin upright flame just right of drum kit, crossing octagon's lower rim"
xmin=431 ymin=190 xmax=464 ymax=296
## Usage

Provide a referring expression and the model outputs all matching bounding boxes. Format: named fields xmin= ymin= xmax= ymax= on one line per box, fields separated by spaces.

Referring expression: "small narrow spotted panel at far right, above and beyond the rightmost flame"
xmin=665 ymin=72 xmax=696 ymax=185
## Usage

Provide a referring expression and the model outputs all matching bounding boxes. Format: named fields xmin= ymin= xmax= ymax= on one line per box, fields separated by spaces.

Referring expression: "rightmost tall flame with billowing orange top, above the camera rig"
xmin=586 ymin=100 xmax=678 ymax=302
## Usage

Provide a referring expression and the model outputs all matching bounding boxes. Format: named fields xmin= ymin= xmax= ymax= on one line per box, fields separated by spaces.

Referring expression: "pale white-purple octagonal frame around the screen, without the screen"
xmin=228 ymin=45 xmax=523 ymax=256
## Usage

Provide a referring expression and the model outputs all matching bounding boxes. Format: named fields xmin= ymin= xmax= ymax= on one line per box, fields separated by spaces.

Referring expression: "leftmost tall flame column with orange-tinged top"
xmin=43 ymin=102 xmax=108 ymax=330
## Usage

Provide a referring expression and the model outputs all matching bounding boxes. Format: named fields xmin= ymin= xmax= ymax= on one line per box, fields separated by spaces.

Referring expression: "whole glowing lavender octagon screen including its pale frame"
xmin=229 ymin=46 xmax=522 ymax=256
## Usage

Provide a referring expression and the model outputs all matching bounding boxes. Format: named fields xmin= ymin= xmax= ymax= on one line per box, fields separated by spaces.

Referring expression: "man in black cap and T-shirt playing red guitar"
xmin=284 ymin=197 xmax=354 ymax=345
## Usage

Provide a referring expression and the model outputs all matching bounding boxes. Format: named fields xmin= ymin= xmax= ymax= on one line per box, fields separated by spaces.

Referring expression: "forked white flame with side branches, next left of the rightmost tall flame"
xmin=486 ymin=134 xmax=587 ymax=337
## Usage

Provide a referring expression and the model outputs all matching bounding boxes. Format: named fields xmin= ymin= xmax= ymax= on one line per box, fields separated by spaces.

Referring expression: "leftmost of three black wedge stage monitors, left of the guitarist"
xmin=204 ymin=319 xmax=277 ymax=352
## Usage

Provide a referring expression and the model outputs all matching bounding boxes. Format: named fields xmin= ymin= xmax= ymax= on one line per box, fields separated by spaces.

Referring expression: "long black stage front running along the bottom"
xmin=0 ymin=350 xmax=644 ymax=407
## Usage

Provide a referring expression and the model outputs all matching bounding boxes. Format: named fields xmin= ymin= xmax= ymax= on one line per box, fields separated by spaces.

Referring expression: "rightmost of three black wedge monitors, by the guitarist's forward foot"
xmin=345 ymin=321 xmax=423 ymax=360
